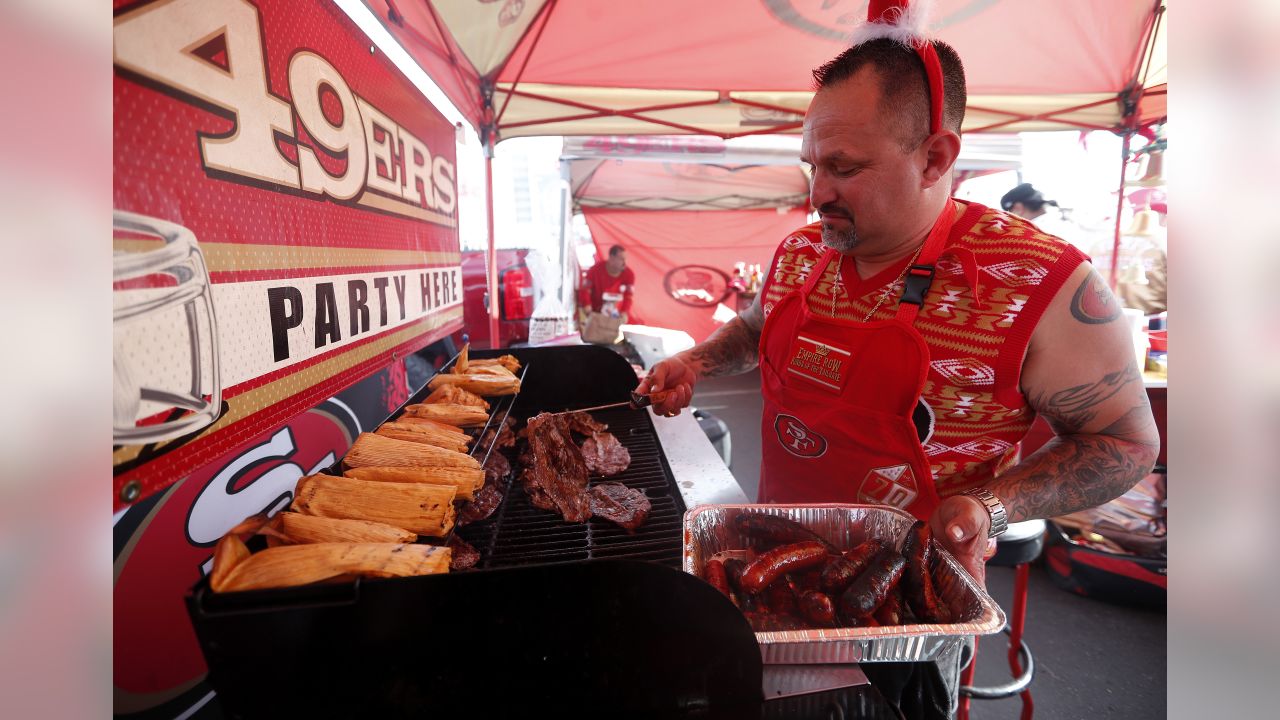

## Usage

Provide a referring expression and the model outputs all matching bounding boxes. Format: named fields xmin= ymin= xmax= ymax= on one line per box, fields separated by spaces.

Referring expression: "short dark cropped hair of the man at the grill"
xmin=813 ymin=37 xmax=968 ymax=150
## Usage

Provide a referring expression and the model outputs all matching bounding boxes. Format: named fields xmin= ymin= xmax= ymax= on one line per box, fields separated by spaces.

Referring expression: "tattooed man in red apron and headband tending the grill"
xmin=640 ymin=8 xmax=1158 ymax=597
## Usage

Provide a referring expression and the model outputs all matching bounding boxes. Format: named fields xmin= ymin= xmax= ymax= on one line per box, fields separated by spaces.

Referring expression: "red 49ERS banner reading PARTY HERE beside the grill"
xmin=113 ymin=0 xmax=462 ymax=510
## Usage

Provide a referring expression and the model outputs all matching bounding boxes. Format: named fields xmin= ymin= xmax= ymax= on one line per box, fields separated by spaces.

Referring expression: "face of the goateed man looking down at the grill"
xmin=800 ymin=68 xmax=936 ymax=255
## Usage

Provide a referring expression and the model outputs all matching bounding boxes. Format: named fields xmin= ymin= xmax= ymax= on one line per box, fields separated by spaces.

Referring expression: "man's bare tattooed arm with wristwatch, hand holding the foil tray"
xmin=932 ymin=264 xmax=1160 ymax=577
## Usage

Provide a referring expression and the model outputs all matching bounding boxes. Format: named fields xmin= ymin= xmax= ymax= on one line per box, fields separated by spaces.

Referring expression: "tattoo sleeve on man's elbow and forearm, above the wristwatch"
xmin=988 ymin=366 xmax=1160 ymax=521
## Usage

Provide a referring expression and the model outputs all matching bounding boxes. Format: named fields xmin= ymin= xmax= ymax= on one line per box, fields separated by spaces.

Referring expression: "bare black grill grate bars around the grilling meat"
xmin=457 ymin=409 xmax=685 ymax=569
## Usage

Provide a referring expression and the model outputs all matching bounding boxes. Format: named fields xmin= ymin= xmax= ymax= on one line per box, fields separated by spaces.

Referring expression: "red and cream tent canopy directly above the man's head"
xmin=365 ymin=0 xmax=1167 ymax=138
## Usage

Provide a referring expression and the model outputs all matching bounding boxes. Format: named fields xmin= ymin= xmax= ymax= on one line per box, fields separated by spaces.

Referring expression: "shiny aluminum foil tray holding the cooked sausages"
xmin=684 ymin=505 xmax=1005 ymax=665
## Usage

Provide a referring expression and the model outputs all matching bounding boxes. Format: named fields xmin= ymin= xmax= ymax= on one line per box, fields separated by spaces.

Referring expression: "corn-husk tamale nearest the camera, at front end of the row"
xmin=210 ymin=536 xmax=453 ymax=592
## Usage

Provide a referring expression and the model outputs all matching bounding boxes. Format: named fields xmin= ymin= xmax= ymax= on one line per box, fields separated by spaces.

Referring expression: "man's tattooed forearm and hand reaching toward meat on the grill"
xmin=637 ymin=293 xmax=764 ymax=415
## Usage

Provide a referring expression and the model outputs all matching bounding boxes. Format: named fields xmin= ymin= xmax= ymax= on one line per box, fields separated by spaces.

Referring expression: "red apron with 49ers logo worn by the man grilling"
xmin=759 ymin=201 xmax=955 ymax=519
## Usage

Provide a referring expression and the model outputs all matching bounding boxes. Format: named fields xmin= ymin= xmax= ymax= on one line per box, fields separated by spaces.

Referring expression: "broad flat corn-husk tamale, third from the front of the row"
xmin=289 ymin=475 xmax=457 ymax=537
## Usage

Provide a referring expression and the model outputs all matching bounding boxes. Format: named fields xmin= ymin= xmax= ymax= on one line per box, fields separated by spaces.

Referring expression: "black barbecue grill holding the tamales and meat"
xmin=187 ymin=346 xmax=819 ymax=719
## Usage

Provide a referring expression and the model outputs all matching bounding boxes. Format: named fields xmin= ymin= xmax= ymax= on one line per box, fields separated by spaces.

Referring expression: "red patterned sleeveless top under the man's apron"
xmin=760 ymin=204 xmax=1085 ymax=497
